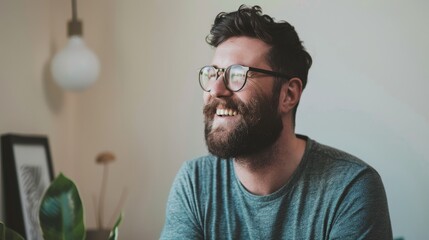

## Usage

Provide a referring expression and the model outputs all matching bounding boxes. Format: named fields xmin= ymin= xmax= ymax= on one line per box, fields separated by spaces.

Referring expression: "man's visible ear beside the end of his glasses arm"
xmin=279 ymin=77 xmax=302 ymax=114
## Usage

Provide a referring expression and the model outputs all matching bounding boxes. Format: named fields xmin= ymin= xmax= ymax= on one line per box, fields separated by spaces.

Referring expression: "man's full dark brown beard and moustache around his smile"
xmin=204 ymin=92 xmax=283 ymax=165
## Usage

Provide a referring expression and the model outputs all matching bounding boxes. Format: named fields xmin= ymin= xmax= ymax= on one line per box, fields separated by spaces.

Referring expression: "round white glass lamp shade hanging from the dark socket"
xmin=51 ymin=36 xmax=100 ymax=91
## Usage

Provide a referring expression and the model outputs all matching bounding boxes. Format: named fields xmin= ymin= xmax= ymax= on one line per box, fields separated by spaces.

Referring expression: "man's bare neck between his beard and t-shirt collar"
xmin=234 ymin=131 xmax=305 ymax=195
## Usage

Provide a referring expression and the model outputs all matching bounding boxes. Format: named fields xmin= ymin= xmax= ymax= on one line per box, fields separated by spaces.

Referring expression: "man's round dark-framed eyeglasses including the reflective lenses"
xmin=199 ymin=64 xmax=290 ymax=92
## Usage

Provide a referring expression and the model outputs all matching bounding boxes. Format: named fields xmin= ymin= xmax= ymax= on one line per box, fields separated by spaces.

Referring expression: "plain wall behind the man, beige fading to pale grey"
xmin=0 ymin=0 xmax=429 ymax=239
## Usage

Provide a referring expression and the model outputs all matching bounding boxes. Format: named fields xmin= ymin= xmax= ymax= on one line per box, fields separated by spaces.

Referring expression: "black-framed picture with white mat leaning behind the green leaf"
xmin=1 ymin=134 xmax=54 ymax=240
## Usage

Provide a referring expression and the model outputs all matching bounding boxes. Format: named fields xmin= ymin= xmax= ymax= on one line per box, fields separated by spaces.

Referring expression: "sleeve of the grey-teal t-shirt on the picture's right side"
xmin=329 ymin=168 xmax=392 ymax=240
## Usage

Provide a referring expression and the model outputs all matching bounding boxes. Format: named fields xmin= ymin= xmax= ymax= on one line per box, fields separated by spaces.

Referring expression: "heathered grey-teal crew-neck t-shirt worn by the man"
xmin=161 ymin=137 xmax=392 ymax=240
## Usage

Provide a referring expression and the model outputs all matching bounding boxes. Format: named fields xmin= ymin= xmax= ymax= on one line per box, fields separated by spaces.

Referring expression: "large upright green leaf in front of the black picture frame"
xmin=39 ymin=173 xmax=85 ymax=240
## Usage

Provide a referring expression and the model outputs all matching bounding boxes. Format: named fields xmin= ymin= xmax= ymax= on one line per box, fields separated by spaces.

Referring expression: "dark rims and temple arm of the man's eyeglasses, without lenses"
xmin=198 ymin=64 xmax=291 ymax=92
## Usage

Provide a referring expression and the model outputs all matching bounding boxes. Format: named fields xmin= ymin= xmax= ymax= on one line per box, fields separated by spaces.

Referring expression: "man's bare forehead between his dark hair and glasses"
xmin=212 ymin=37 xmax=271 ymax=68
